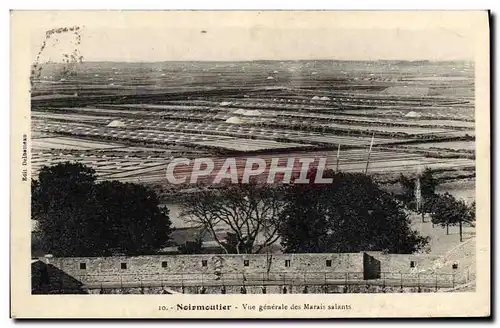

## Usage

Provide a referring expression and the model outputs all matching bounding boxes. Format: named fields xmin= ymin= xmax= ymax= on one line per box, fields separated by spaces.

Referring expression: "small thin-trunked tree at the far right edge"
xmin=431 ymin=193 xmax=476 ymax=241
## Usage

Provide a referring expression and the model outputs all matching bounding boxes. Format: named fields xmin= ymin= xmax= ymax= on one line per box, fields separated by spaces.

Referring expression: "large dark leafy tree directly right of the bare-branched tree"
xmin=279 ymin=169 xmax=428 ymax=253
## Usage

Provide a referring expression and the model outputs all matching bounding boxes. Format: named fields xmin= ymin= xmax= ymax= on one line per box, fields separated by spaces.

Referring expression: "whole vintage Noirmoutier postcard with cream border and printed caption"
xmin=10 ymin=11 xmax=490 ymax=318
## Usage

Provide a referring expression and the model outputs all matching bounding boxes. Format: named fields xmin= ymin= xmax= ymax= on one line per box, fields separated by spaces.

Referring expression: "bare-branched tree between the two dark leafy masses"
xmin=181 ymin=182 xmax=282 ymax=254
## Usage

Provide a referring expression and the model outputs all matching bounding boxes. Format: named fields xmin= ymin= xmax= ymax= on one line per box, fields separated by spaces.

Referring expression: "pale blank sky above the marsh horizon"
xmin=25 ymin=11 xmax=474 ymax=62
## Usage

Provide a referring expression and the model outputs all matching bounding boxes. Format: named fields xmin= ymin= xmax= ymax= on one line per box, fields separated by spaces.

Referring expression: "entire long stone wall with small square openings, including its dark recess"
xmin=36 ymin=252 xmax=468 ymax=293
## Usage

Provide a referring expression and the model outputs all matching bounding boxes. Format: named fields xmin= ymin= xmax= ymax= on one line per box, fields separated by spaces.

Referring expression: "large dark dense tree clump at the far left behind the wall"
xmin=32 ymin=162 xmax=172 ymax=256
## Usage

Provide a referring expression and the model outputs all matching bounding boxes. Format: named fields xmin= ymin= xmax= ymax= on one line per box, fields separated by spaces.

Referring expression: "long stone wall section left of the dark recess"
xmin=50 ymin=253 xmax=363 ymax=284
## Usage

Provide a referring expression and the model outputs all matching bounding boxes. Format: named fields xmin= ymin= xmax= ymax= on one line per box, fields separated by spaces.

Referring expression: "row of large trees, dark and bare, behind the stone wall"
xmin=32 ymin=163 xmax=428 ymax=256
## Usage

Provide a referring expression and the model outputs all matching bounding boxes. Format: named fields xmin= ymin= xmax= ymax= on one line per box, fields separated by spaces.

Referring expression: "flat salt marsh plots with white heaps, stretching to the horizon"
xmin=31 ymin=60 xmax=475 ymax=206
